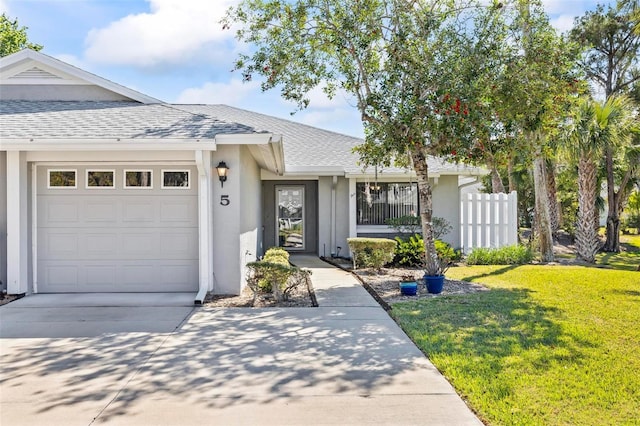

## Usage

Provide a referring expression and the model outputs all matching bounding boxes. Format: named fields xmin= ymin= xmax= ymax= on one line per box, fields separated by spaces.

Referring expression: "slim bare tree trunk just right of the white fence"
xmin=531 ymin=141 xmax=554 ymax=262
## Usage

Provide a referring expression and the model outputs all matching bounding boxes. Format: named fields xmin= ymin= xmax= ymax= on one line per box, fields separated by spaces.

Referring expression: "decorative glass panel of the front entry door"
xmin=276 ymin=186 xmax=304 ymax=250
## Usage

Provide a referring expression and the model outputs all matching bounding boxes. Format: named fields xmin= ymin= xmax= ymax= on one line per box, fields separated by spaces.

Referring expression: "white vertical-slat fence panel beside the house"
xmin=460 ymin=191 xmax=518 ymax=253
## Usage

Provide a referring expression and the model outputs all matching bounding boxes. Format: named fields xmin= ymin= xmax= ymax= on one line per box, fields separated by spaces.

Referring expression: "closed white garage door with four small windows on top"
xmin=36 ymin=165 xmax=198 ymax=293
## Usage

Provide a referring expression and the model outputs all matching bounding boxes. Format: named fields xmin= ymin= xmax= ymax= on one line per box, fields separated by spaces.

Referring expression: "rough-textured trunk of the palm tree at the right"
xmin=576 ymin=155 xmax=600 ymax=263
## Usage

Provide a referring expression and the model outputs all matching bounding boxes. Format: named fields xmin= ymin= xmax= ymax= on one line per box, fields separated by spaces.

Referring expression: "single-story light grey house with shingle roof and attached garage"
xmin=0 ymin=50 xmax=483 ymax=302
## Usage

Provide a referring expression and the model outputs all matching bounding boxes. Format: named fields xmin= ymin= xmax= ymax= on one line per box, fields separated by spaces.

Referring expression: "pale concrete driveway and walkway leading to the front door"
xmin=0 ymin=256 xmax=482 ymax=426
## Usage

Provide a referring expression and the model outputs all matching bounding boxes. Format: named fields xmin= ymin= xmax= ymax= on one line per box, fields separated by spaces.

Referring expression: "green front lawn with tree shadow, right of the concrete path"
xmin=391 ymin=264 xmax=640 ymax=425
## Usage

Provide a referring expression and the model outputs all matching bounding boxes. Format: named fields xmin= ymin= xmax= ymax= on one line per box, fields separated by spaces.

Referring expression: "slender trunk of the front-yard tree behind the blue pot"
xmin=411 ymin=146 xmax=442 ymax=275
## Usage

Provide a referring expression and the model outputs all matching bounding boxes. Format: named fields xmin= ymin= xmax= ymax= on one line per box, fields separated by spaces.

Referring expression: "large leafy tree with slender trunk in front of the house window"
xmin=222 ymin=0 xmax=512 ymax=282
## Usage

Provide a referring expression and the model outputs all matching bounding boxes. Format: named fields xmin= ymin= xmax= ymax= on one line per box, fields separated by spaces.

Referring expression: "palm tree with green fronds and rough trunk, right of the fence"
xmin=565 ymin=96 xmax=635 ymax=263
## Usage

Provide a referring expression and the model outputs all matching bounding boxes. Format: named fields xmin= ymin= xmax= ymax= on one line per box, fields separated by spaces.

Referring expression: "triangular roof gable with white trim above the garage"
xmin=0 ymin=49 xmax=161 ymax=104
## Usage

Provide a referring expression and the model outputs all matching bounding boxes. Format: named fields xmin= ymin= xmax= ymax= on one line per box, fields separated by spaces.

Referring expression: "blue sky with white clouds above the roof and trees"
xmin=0 ymin=0 xmax=610 ymax=137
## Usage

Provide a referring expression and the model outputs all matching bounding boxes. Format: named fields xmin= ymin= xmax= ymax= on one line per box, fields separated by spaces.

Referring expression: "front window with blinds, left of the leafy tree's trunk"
xmin=356 ymin=182 xmax=419 ymax=225
